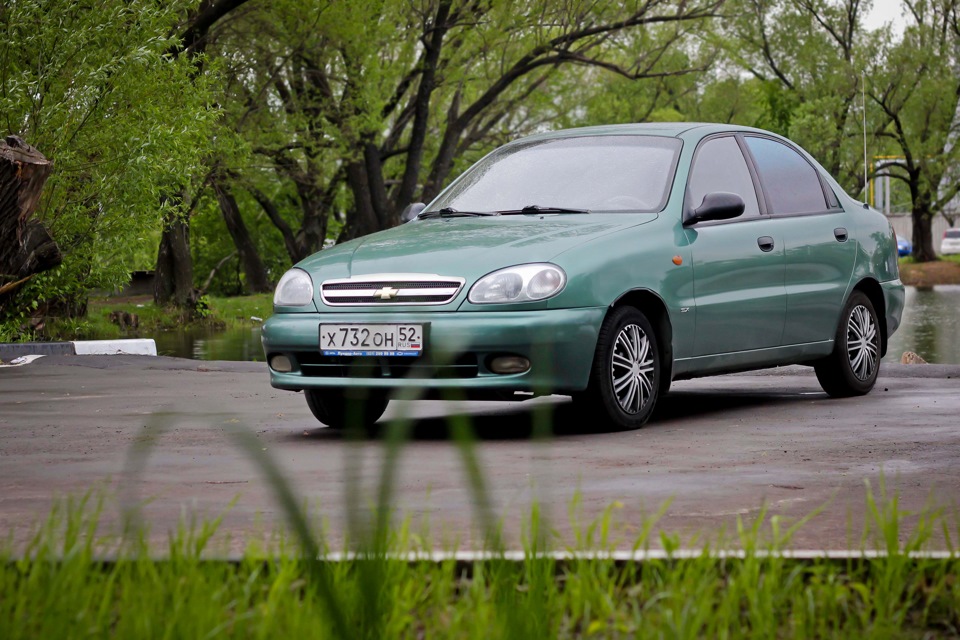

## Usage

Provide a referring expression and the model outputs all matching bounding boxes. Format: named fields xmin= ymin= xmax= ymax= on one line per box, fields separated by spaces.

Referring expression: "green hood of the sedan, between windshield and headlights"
xmin=298 ymin=213 xmax=657 ymax=282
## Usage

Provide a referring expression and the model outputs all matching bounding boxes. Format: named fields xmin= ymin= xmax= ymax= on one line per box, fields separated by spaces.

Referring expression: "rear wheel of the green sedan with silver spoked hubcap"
xmin=814 ymin=291 xmax=880 ymax=398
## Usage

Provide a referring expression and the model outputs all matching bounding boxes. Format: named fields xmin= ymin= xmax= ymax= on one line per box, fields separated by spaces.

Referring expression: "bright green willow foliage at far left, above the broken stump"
xmin=0 ymin=0 xmax=217 ymax=322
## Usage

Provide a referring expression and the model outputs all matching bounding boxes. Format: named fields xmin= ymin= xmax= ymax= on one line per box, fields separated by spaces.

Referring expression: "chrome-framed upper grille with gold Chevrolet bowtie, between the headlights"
xmin=320 ymin=274 xmax=464 ymax=307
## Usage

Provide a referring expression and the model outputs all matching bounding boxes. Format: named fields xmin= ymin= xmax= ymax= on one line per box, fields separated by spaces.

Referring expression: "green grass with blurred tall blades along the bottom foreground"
xmin=0 ymin=415 xmax=960 ymax=640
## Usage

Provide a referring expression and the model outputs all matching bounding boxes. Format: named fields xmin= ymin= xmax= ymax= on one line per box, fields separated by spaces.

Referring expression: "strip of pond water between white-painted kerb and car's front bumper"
xmin=156 ymin=326 xmax=263 ymax=362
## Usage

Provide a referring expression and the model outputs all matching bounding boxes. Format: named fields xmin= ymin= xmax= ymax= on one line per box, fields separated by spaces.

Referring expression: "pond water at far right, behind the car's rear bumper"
xmin=883 ymin=285 xmax=960 ymax=364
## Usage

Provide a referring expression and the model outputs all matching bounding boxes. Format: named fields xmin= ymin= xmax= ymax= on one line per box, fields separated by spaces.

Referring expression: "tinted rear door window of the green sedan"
xmin=745 ymin=136 xmax=829 ymax=215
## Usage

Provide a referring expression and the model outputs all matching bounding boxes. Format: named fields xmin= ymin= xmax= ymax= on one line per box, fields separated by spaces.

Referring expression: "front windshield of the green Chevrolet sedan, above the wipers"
xmin=428 ymin=136 xmax=681 ymax=212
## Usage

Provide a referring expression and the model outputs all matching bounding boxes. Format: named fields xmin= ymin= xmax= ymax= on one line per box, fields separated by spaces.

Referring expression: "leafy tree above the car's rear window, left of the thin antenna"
xmin=723 ymin=0 xmax=880 ymax=194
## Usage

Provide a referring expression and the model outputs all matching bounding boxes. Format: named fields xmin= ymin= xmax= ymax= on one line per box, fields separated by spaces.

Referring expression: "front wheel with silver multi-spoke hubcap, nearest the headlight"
xmin=574 ymin=307 xmax=661 ymax=431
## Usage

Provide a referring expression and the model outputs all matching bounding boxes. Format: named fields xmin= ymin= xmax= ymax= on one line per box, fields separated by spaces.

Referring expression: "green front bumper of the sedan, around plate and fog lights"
xmin=261 ymin=307 xmax=606 ymax=393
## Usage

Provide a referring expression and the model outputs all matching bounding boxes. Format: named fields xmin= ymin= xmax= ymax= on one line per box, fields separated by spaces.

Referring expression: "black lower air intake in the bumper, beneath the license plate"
xmin=296 ymin=353 xmax=472 ymax=378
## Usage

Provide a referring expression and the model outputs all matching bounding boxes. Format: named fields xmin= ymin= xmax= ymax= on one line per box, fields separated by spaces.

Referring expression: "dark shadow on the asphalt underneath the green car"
xmin=289 ymin=390 xmax=827 ymax=442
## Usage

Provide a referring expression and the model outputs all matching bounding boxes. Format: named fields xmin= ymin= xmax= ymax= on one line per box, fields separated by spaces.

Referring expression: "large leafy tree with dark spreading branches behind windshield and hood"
xmin=209 ymin=0 xmax=721 ymax=276
